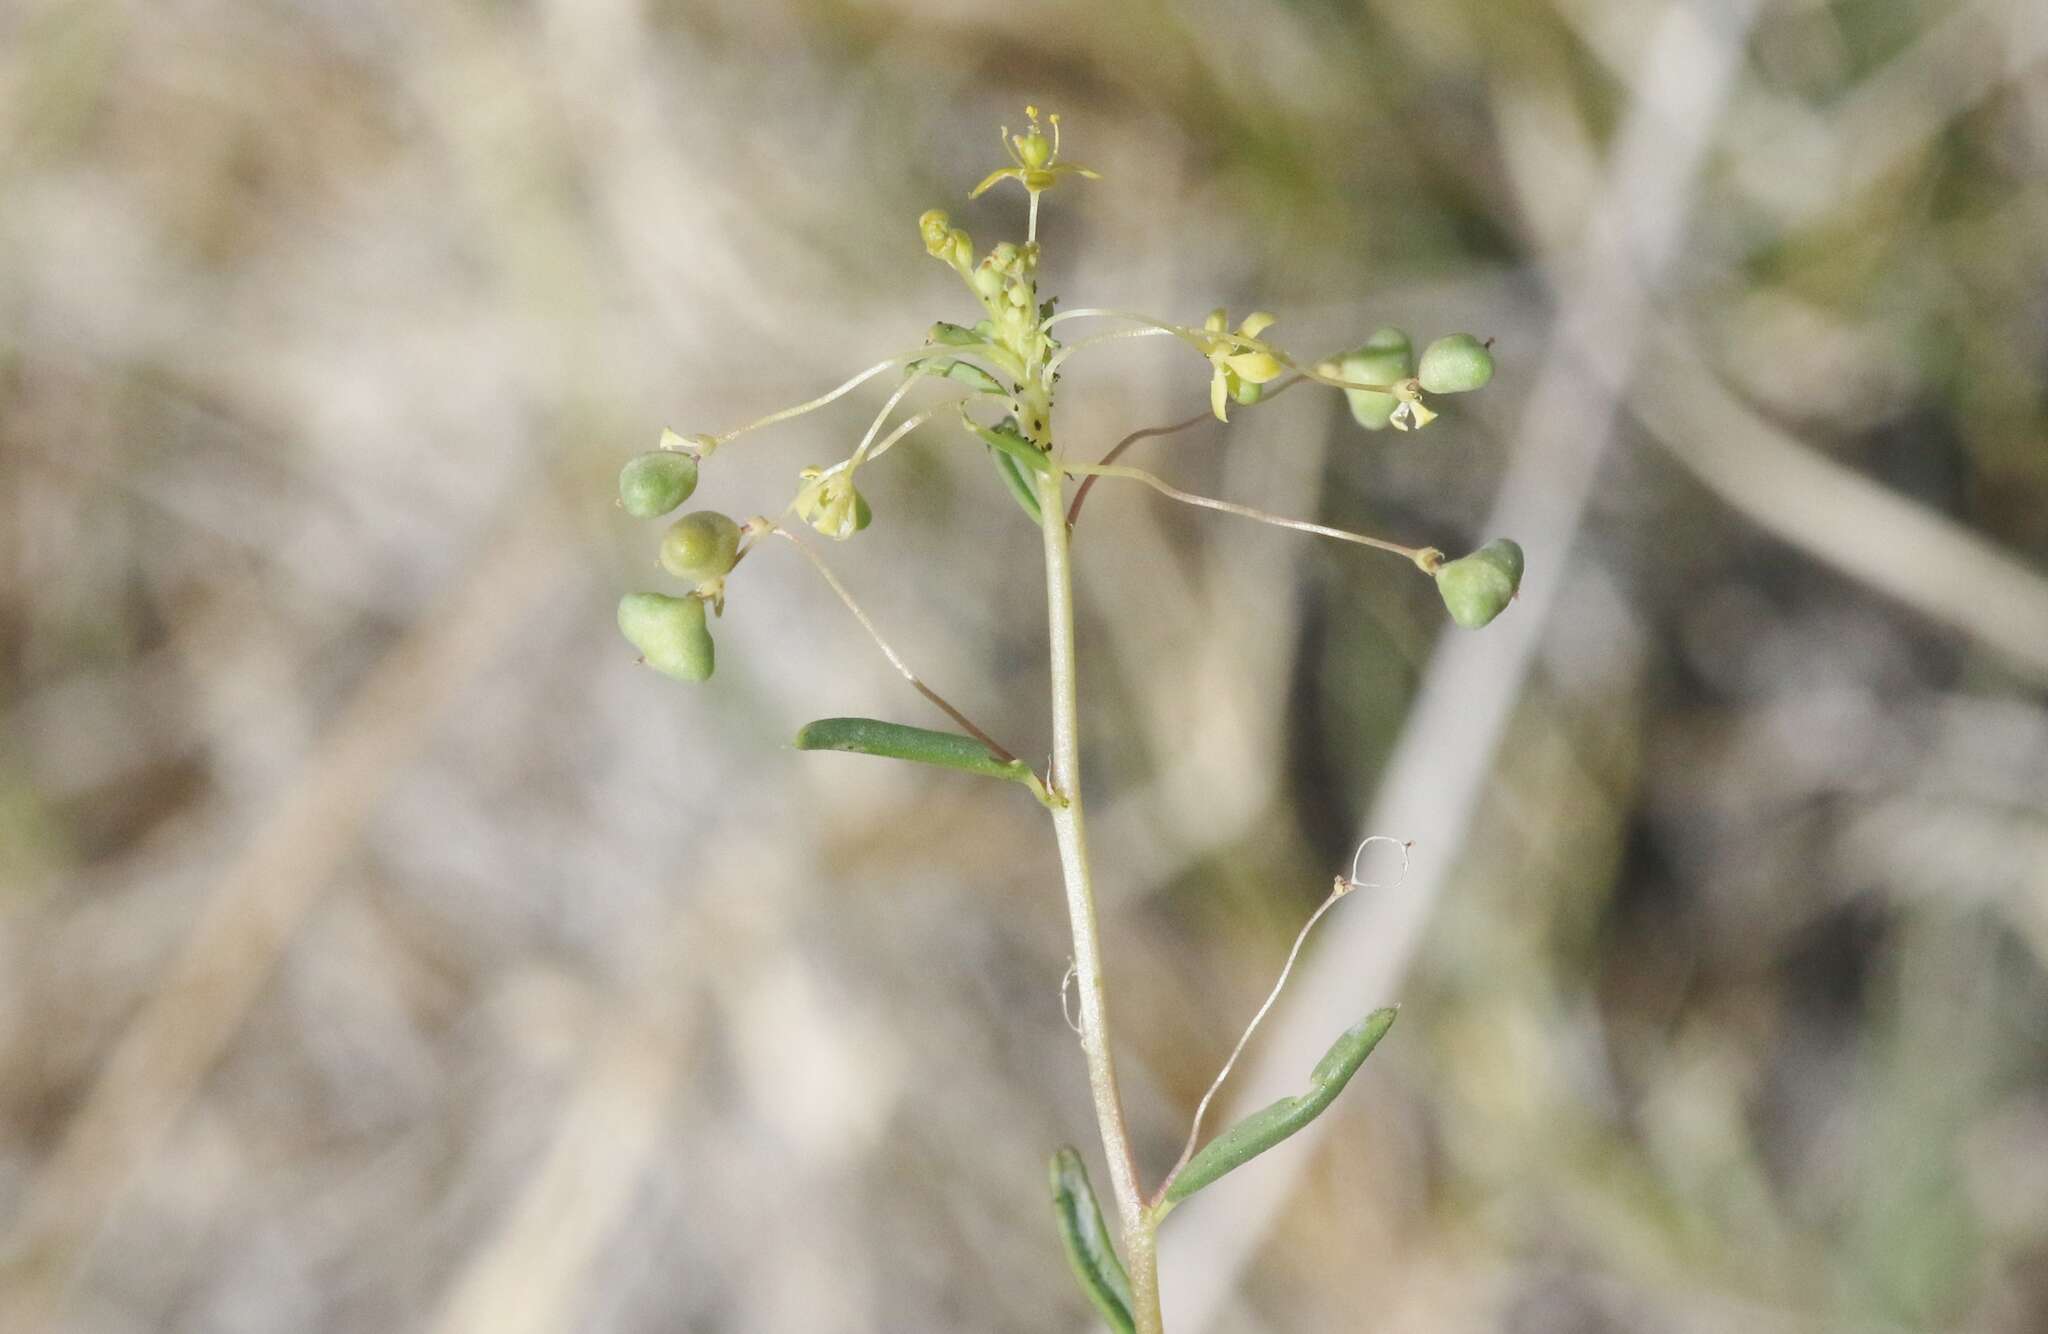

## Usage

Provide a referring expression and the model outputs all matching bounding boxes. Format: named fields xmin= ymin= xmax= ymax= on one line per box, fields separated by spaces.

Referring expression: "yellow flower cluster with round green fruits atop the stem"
xmin=618 ymin=107 xmax=1520 ymax=680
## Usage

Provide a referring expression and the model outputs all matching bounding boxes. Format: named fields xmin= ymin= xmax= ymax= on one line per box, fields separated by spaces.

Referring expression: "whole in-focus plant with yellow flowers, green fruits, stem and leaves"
xmin=618 ymin=107 xmax=1522 ymax=1332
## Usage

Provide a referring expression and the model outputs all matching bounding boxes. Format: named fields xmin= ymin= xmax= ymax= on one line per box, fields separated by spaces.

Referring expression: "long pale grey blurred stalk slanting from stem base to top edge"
xmin=1165 ymin=4 xmax=1755 ymax=1330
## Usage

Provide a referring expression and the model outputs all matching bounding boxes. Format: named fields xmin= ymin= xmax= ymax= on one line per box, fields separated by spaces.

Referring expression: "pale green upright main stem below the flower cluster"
xmin=1038 ymin=461 xmax=1165 ymax=1334
